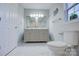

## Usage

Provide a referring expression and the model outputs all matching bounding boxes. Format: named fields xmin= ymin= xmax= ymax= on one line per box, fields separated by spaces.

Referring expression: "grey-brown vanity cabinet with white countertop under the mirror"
xmin=24 ymin=28 xmax=49 ymax=42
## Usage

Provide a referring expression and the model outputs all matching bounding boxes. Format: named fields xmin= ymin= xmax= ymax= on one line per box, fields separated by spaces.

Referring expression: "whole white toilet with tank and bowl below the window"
xmin=47 ymin=31 xmax=79 ymax=56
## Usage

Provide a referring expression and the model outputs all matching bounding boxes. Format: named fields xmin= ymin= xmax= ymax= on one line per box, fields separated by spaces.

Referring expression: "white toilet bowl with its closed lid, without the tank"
xmin=47 ymin=41 xmax=71 ymax=56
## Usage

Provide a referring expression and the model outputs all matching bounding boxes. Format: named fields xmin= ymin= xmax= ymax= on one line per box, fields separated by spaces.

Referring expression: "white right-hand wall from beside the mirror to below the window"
xmin=49 ymin=3 xmax=79 ymax=40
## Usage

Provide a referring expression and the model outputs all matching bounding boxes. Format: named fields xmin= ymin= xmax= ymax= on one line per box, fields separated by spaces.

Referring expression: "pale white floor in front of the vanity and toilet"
xmin=8 ymin=43 xmax=52 ymax=56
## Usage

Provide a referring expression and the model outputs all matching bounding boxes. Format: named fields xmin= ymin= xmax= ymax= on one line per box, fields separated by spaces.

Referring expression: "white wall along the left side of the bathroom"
xmin=0 ymin=4 xmax=23 ymax=55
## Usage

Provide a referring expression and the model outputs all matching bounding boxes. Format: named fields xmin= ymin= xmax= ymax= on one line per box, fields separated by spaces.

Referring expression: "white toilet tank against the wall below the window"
xmin=64 ymin=31 xmax=79 ymax=45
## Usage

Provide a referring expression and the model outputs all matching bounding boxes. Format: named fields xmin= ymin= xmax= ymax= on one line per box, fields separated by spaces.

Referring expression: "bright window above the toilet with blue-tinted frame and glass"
xmin=65 ymin=3 xmax=79 ymax=21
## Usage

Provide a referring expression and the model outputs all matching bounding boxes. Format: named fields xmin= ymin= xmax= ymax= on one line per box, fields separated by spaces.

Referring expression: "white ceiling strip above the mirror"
xmin=21 ymin=3 xmax=53 ymax=9
